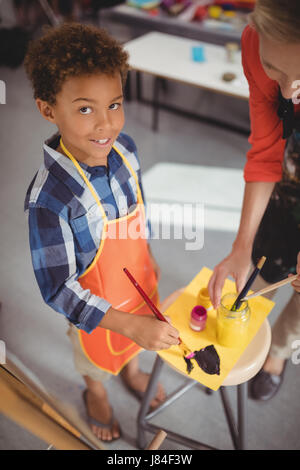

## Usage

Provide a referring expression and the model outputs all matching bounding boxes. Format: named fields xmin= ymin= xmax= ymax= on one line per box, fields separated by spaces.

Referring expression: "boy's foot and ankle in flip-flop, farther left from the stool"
xmin=84 ymin=389 xmax=121 ymax=442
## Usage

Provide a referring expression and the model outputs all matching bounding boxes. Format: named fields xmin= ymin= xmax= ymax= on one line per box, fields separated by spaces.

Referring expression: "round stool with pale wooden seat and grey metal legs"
xmin=137 ymin=289 xmax=271 ymax=449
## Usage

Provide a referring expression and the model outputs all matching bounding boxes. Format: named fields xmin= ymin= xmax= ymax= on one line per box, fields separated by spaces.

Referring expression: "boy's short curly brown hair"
xmin=24 ymin=23 xmax=129 ymax=105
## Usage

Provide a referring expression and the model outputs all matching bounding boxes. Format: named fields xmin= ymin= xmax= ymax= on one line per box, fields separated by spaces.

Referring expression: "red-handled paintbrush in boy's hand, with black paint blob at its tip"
xmin=123 ymin=268 xmax=220 ymax=375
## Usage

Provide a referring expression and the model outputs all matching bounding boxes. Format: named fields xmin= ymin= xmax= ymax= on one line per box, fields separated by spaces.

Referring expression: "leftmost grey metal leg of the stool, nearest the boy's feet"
xmin=137 ymin=355 xmax=163 ymax=449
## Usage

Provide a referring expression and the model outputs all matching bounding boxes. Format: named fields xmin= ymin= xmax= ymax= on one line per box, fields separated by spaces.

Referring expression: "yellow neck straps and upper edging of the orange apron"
xmin=60 ymin=138 xmax=145 ymax=279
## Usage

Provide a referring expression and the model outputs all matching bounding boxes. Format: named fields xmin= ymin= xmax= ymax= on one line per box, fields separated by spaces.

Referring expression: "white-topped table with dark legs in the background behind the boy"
xmin=125 ymin=32 xmax=249 ymax=133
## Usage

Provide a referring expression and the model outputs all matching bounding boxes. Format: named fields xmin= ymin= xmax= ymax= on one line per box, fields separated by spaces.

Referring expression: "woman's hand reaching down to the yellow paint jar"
xmin=207 ymin=249 xmax=251 ymax=309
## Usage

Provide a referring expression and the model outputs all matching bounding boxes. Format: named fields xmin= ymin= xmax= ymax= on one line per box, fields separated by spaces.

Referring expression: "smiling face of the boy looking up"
xmin=37 ymin=73 xmax=124 ymax=166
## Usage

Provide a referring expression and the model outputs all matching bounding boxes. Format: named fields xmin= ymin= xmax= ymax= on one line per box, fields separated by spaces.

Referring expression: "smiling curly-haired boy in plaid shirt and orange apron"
xmin=25 ymin=24 xmax=179 ymax=440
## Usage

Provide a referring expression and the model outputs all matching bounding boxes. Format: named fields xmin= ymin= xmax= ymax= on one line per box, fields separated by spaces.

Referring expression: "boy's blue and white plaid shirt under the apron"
xmin=25 ymin=133 xmax=149 ymax=333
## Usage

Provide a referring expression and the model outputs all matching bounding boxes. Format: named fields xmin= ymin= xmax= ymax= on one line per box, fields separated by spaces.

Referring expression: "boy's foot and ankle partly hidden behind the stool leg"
xmin=121 ymin=367 xmax=166 ymax=410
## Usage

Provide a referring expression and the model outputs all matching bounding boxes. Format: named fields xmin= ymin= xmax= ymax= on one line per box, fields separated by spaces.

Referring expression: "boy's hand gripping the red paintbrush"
xmin=126 ymin=315 xmax=179 ymax=351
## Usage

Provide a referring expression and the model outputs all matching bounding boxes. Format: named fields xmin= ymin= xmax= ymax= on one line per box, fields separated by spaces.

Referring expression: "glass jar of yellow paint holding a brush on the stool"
xmin=217 ymin=293 xmax=251 ymax=348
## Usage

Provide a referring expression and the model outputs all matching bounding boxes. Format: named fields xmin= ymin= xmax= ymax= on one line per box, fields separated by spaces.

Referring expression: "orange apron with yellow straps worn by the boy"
xmin=60 ymin=140 xmax=158 ymax=375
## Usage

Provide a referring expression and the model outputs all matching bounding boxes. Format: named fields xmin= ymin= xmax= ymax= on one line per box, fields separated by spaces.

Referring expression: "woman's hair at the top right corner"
xmin=250 ymin=0 xmax=300 ymax=43
